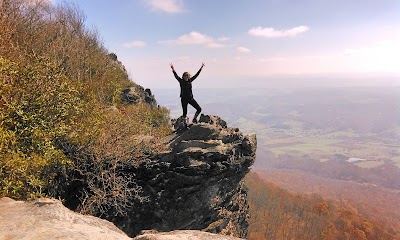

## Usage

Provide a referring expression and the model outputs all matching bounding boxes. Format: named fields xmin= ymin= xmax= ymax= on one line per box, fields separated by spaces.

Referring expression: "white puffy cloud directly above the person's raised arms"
xmin=160 ymin=31 xmax=228 ymax=48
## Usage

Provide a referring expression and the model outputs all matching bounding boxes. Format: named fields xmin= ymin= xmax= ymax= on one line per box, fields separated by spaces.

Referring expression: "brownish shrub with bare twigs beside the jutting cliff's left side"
xmin=62 ymin=105 xmax=171 ymax=216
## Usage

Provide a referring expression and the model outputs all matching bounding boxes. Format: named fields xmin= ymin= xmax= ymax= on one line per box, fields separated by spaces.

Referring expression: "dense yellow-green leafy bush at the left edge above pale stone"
xmin=0 ymin=57 xmax=84 ymax=198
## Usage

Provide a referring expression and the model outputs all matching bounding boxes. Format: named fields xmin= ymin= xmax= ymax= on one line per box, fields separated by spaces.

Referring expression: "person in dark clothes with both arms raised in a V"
xmin=170 ymin=63 xmax=205 ymax=123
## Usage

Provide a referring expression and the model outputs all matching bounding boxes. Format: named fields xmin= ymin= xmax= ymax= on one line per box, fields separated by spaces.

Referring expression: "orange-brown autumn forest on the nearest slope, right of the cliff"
xmin=246 ymin=173 xmax=398 ymax=240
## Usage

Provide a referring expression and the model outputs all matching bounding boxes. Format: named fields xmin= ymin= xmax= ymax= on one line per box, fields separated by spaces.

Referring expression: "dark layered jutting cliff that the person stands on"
xmin=115 ymin=115 xmax=256 ymax=237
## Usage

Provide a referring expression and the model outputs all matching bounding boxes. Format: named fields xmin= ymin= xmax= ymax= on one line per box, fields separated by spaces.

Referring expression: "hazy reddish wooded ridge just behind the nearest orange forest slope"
xmin=257 ymin=169 xmax=400 ymax=234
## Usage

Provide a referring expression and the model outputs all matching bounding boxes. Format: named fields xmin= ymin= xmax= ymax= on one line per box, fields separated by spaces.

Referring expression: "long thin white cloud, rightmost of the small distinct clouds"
xmin=248 ymin=26 xmax=310 ymax=38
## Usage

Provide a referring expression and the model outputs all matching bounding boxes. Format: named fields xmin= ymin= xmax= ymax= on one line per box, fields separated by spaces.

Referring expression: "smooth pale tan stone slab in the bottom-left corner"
xmin=0 ymin=197 xmax=131 ymax=240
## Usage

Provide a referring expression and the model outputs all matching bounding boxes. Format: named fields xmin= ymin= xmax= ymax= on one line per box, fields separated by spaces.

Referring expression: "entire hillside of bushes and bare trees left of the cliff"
xmin=0 ymin=0 xmax=171 ymax=212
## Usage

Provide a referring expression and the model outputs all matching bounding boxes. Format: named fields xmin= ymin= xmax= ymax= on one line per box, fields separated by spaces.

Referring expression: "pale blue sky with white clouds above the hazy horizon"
xmin=52 ymin=0 xmax=400 ymax=88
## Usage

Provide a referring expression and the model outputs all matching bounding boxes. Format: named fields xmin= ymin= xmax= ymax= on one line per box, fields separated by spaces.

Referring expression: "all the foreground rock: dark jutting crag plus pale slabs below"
xmin=0 ymin=115 xmax=257 ymax=240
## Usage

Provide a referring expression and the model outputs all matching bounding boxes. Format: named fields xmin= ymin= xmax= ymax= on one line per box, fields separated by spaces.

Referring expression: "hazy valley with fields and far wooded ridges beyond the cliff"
xmin=154 ymin=82 xmax=400 ymax=236
